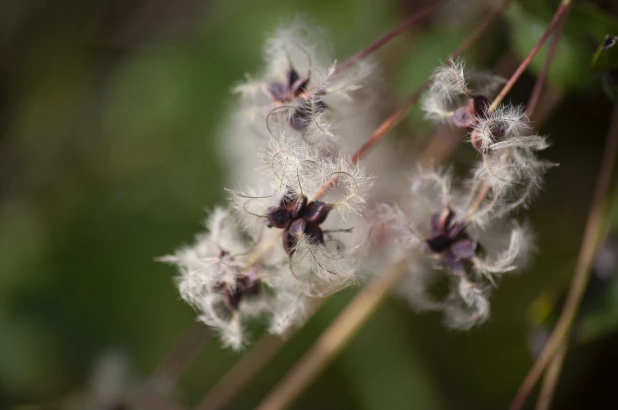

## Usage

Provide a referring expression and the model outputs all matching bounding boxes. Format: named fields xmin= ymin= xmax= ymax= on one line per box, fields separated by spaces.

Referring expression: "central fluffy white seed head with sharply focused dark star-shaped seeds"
xmin=232 ymin=138 xmax=367 ymax=295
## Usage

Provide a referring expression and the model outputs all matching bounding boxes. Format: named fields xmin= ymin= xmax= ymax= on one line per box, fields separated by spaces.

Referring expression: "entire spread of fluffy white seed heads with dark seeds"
xmin=160 ymin=23 xmax=553 ymax=349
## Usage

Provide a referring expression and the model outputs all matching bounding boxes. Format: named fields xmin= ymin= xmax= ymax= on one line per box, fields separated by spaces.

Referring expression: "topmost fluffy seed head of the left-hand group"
xmin=235 ymin=22 xmax=372 ymax=148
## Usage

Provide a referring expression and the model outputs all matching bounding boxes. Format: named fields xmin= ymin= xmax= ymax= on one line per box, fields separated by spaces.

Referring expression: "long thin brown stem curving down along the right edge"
xmin=510 ymin=106 xmax=618 ymax=410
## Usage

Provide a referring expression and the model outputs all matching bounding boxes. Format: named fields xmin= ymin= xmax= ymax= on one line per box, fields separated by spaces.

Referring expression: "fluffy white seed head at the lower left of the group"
xmin=159 ymin=208 xmax=307 ymax=349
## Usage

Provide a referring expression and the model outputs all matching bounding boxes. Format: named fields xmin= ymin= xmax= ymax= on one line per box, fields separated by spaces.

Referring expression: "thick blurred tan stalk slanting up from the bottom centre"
xmin=257 ymin=261 xmax=405 ymax=410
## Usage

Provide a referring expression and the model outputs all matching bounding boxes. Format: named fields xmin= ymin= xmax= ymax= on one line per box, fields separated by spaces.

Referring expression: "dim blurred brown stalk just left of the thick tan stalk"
xmin=195 ymin=335 xmax=285 ymax=410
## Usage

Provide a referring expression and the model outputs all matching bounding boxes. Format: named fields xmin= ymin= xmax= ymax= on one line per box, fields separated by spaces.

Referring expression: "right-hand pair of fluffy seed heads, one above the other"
xmin=368 ymin=60 xmax=554 ymax=329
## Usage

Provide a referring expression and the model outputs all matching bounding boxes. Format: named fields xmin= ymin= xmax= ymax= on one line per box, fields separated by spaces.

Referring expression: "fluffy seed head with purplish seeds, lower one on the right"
xmin=378 ymin=170 xmax=532 ymax=329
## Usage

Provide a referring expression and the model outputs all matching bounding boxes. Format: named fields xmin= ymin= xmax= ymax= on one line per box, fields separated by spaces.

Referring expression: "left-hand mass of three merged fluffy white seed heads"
xmin=159 ymin=22 xmax=377 ymax=349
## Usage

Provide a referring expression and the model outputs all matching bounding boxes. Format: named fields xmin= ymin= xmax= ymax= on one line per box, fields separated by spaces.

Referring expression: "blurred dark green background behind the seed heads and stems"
xmin=0 ymin=0 xmax=618 ymax=410
